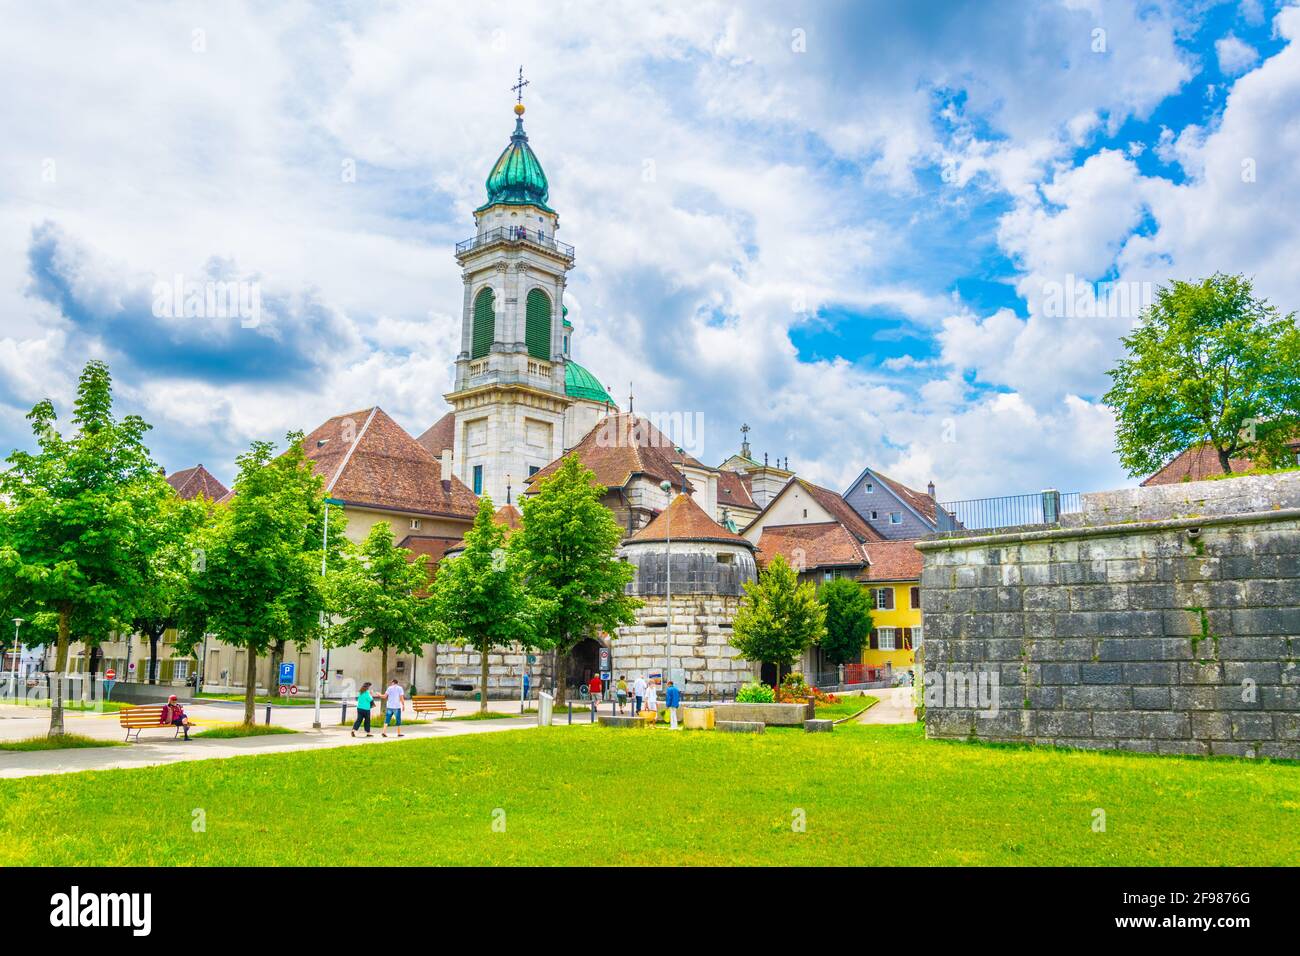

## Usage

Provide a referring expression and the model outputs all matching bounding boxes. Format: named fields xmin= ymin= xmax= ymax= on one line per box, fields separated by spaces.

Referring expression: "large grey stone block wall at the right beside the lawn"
xmin=919 ymin=475 xmax=1300 ymax=760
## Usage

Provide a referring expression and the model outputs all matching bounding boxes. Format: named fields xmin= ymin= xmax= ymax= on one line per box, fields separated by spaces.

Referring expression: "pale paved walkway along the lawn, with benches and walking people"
xmin=0 ymin=701 xmax=569 ymax=778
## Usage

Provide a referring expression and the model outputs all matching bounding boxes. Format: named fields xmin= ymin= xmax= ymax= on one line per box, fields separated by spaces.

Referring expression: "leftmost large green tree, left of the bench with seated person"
xmin=0 ymin=360 xmax=172 ymax=737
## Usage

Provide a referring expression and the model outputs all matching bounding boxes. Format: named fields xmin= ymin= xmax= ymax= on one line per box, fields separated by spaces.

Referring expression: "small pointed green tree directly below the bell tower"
xmin=433 ymin=498 xmax=540 ymax=713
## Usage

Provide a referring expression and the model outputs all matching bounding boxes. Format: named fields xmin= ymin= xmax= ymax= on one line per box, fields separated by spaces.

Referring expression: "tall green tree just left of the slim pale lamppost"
xmin=177 ymin=432 xmax=345 ymax=727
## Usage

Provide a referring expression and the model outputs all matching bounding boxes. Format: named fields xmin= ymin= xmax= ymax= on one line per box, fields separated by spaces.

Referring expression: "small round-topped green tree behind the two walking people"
xmin=326 ymin=522 xmax=434 ymax=697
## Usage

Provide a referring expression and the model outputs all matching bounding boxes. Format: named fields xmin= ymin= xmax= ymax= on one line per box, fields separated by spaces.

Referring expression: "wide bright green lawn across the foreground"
xmin=0 ymin=723 xmax=1300 ymax=866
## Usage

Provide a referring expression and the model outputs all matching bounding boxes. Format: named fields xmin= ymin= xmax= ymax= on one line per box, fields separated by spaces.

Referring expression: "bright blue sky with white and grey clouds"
xmin=0 ymin=0 xmax=1300 ymax=499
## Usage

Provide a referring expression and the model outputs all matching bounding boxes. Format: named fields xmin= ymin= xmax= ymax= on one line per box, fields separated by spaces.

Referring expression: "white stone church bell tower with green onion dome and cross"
xmin=446 ymin=70 xmax=575 ymax=505
